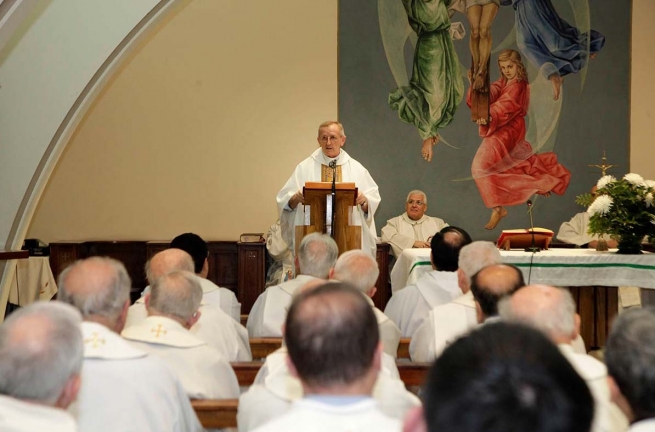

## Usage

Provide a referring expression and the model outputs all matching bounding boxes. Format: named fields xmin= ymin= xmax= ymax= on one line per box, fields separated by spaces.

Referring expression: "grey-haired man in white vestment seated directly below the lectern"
xmin=246 ymin=233 xmax=339 ymax=338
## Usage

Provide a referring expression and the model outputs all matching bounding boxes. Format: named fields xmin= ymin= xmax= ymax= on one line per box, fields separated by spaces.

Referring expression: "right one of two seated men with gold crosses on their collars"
xmin=122 ymin=271 xmax=239 ymax=399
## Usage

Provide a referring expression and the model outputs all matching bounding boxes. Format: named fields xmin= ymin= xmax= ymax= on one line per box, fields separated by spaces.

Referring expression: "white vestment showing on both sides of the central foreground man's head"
xmin=237 ymin=348 xmax=421 ymax=432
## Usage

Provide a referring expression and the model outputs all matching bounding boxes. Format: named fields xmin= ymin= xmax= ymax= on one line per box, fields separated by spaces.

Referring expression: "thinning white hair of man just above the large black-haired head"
xmin=498 ymin=286 xmax=576 ymax=338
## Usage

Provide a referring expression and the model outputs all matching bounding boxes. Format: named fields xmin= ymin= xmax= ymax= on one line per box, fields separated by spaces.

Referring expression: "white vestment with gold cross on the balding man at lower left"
xmin=70 ymin=321 xmax=202 ymax=432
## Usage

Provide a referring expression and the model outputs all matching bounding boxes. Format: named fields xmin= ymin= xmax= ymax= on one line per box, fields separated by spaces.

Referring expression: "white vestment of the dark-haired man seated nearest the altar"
xmin=384 ymin=270 xmax=462 ymax=338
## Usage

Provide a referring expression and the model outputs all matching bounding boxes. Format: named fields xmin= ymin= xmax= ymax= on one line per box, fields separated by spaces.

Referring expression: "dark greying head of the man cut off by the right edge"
xmin=605 ymin=307 xmax=655 ymax=432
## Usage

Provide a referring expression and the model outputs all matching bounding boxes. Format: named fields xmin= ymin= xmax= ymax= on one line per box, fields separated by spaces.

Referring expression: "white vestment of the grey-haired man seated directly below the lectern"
xmin=246 ymin=275 xmax=316 ymax=338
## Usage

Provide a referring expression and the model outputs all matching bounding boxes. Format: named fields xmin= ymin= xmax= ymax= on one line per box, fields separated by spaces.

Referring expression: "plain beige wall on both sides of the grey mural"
xmin=28 ymin=0 xmax=655 ymax=242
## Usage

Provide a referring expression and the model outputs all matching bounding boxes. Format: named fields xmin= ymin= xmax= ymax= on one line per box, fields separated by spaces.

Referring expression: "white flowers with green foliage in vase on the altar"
xmin=576 ymin=173 xmax=655 ymax=253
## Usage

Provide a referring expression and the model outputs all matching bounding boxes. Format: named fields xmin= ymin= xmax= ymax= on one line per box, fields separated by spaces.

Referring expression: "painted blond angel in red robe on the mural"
xmin=467 ymin=50 xmax=571 ymax=230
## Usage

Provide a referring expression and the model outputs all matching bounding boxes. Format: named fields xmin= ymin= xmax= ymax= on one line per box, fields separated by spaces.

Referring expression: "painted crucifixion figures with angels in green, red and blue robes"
xmin=378 ymin=0 xmax=605 ymax=230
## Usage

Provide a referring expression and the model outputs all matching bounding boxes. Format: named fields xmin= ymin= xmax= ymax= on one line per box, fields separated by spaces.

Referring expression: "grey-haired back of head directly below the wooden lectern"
xmin=298 ymin=233 xmax=339 ymax=279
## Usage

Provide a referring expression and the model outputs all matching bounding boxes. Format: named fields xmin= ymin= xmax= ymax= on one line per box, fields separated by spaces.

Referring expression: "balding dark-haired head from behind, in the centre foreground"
xmin=284 ymin=283 xmax=382 ymax=395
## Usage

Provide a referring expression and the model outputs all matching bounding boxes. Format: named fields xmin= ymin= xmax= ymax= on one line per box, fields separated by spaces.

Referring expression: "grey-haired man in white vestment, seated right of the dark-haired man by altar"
xmin=410 ymin=241 xmax=503 ymax=362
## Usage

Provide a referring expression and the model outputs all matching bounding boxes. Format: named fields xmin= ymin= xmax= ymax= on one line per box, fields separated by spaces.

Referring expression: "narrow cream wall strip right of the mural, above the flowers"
xmin=630 ymin=0 xmax=655 ymax=179
